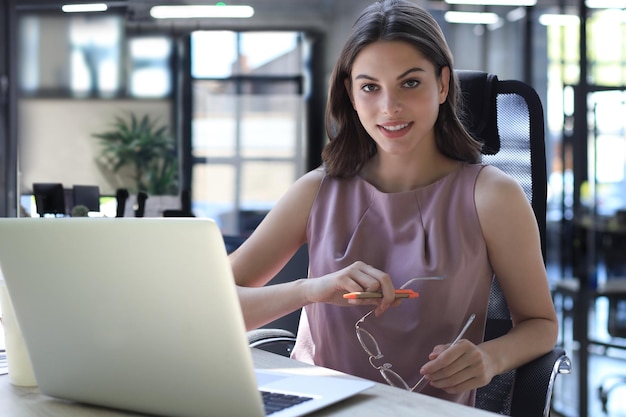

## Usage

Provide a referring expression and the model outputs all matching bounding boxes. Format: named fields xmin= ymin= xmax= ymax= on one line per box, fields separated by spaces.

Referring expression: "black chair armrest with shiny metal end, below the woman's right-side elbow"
xmin=511 ymin=348 xmax=572 ymax=417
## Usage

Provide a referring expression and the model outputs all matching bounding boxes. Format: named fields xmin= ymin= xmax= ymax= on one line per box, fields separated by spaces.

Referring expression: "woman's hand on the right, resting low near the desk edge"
xmin=420 ymin=339 xmax=493 ymax=394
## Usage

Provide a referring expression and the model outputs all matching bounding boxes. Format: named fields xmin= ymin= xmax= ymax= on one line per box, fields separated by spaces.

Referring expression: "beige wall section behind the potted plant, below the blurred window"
xmin=18 ymin=99 xmax=171 ymax=194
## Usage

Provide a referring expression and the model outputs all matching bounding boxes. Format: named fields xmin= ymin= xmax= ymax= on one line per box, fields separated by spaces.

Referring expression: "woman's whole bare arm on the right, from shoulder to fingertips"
xmin=422 ymin=166 xmax=558 ymax=392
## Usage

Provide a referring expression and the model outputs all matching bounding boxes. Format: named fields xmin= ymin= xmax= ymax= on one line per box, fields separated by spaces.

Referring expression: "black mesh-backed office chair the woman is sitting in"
xmin=248 ymin=70 xmax=571 ymax=417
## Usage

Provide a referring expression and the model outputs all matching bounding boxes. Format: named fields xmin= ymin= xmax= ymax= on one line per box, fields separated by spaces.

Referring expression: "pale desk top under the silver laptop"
xmin=0 ymin=349 xmax=496 ymax=417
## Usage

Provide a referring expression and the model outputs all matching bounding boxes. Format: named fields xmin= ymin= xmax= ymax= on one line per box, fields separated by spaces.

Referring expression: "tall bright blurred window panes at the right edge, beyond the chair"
xmin=546 ymin=9 xmax=626 ymax=222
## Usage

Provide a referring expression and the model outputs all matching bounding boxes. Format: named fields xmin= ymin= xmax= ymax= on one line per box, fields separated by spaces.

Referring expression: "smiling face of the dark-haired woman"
xmin=345 ymin=41 xmax=450 ymax=158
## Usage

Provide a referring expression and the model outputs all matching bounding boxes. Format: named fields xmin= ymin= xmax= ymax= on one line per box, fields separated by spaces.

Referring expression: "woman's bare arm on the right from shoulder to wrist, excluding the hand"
xmin=476 ymin=167 xmax=558 ymax=374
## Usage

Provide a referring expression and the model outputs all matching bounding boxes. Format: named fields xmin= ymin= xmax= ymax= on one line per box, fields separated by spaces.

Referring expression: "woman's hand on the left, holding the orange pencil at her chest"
xmin=305 ymin=261 xmax=400 ymax=316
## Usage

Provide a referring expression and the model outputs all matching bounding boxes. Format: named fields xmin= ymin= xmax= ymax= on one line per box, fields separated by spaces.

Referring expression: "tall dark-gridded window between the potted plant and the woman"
xmin=191 ymin=31 xmax=306 ymax=234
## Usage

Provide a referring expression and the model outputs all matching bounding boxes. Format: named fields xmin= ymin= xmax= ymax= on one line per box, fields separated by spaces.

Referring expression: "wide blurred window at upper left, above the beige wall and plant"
xmin=19 ymin=14 xmax=173 ymax=98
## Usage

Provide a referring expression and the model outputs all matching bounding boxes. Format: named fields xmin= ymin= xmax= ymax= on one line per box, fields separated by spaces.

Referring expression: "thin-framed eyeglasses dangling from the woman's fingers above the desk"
xmin=354 ymin=304 xmax=476 ymax=392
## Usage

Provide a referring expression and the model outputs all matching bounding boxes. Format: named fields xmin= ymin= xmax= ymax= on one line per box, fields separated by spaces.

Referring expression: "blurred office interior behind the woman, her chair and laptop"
xmin=0 ymin=0 xmax=626 ymax=416
